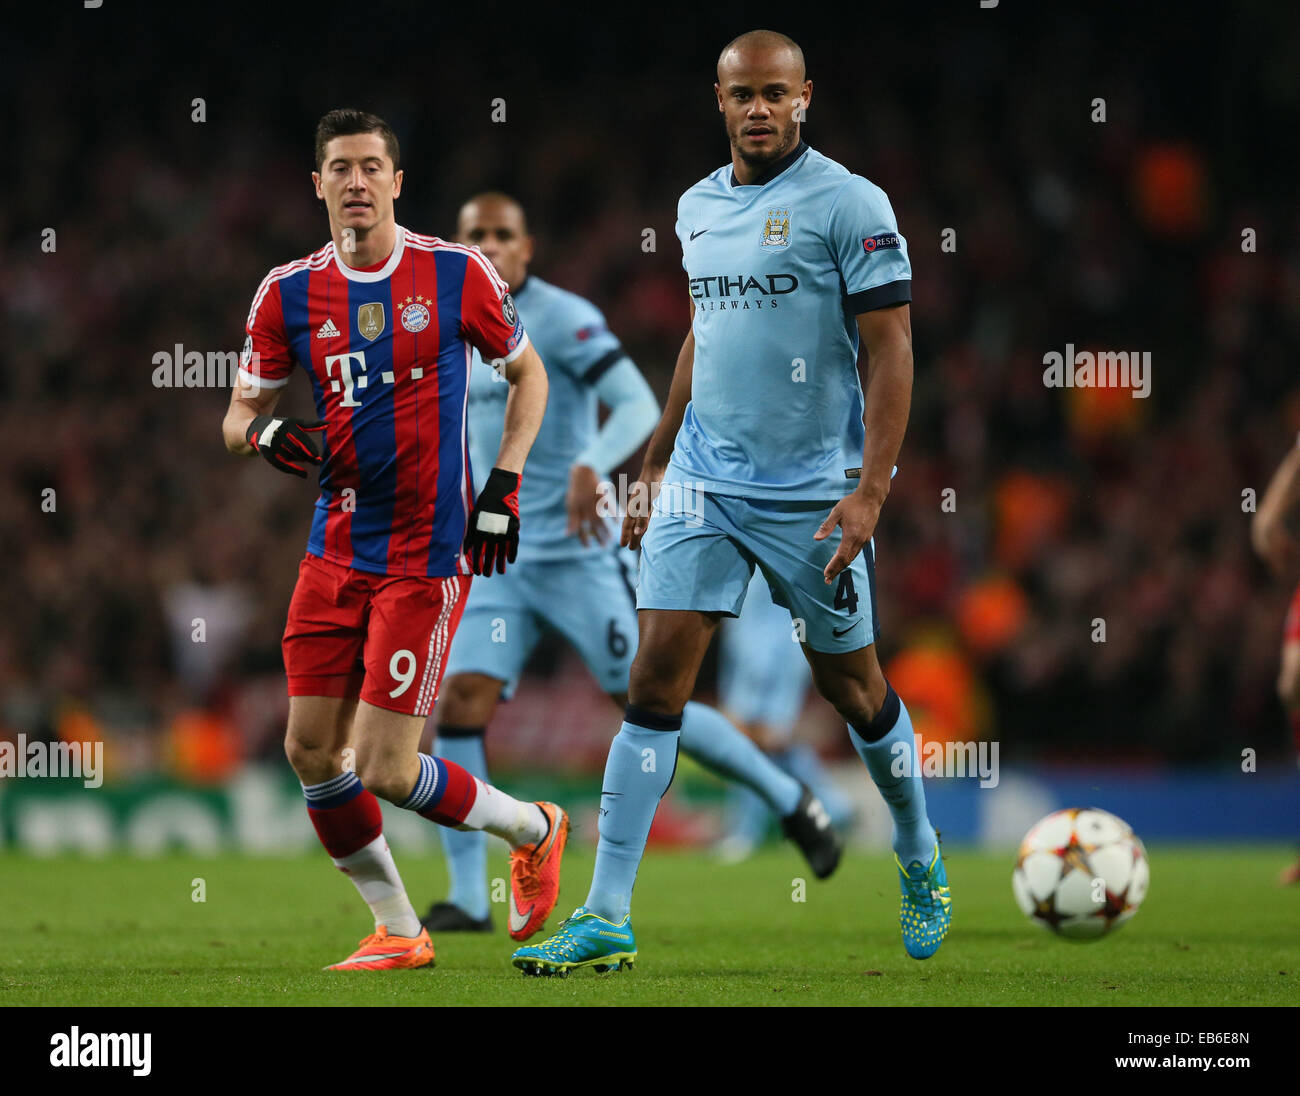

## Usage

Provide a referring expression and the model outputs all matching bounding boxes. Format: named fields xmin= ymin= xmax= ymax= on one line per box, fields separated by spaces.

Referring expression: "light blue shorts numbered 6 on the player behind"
xmin=446 ymin=546 xmax=637 ymax=699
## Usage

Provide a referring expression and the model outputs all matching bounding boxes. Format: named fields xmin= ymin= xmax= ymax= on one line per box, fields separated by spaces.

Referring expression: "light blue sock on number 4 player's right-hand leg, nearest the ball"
xmin=849 ymin=685 xmax=935 ymax=867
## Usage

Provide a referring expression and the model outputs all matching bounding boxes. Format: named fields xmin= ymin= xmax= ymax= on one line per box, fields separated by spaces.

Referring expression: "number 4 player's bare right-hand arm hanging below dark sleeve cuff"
xmin=814 ymin=304 xmax=911 ymax=584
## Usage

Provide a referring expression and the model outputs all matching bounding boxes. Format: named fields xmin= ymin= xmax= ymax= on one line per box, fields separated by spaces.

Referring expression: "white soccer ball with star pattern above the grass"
xmin=1011 ymin=807 xmax=1151 ymax=940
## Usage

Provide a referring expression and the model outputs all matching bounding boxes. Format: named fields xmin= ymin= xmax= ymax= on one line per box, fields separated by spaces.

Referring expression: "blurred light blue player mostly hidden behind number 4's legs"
xmin=712 ymin=571 xmax=853 ymax=863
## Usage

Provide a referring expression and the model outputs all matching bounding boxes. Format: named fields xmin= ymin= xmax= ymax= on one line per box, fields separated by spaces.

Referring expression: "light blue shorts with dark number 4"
xmin=637 ymin=490 xmax=880 ymax=653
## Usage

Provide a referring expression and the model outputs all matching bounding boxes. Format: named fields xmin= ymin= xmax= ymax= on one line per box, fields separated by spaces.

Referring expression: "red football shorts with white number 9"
xmin=283 ymin=555 xmax=473 ymax=715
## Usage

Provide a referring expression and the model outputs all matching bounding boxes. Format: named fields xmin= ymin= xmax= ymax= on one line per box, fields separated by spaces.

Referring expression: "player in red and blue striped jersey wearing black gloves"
xmin=222 ymin=111 xmax=568 ymax=970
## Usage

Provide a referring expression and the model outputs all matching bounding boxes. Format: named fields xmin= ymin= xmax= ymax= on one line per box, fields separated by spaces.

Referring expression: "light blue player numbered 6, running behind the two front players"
xmin=424 ymin=194 xmax=840 ymax=936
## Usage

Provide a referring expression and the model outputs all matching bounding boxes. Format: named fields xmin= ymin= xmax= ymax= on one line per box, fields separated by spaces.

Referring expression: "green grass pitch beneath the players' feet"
xmin=0 ymin=845 xmax=1300 ymax=1005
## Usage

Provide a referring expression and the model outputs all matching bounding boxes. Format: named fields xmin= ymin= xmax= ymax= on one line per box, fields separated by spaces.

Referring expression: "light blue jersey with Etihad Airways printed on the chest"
xmin=665 ymin=142 xmax=911 ymax=501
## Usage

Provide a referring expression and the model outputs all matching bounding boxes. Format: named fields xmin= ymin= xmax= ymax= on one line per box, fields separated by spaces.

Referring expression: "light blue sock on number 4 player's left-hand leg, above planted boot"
xmin=586 ymin=705 xmax=681 ymax=923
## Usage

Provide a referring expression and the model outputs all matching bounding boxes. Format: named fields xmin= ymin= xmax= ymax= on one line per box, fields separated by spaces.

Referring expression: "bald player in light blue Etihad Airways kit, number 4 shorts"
xmin=512 ymin=31 xmax=952 ymax=974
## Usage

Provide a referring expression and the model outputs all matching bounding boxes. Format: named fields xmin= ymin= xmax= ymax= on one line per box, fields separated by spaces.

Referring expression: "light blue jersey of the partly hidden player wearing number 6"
xmin=467 ymin=274 xmax=627 ymax=560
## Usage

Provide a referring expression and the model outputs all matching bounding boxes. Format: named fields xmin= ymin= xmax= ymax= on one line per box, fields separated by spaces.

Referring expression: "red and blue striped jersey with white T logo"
xmin=239 ymin=225 xmax=528 ymax=577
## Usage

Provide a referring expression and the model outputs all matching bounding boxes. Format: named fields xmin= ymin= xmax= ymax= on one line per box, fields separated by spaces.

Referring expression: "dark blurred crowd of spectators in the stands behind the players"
xmin=0 ymin=3 xmax=1300 ymax=779
